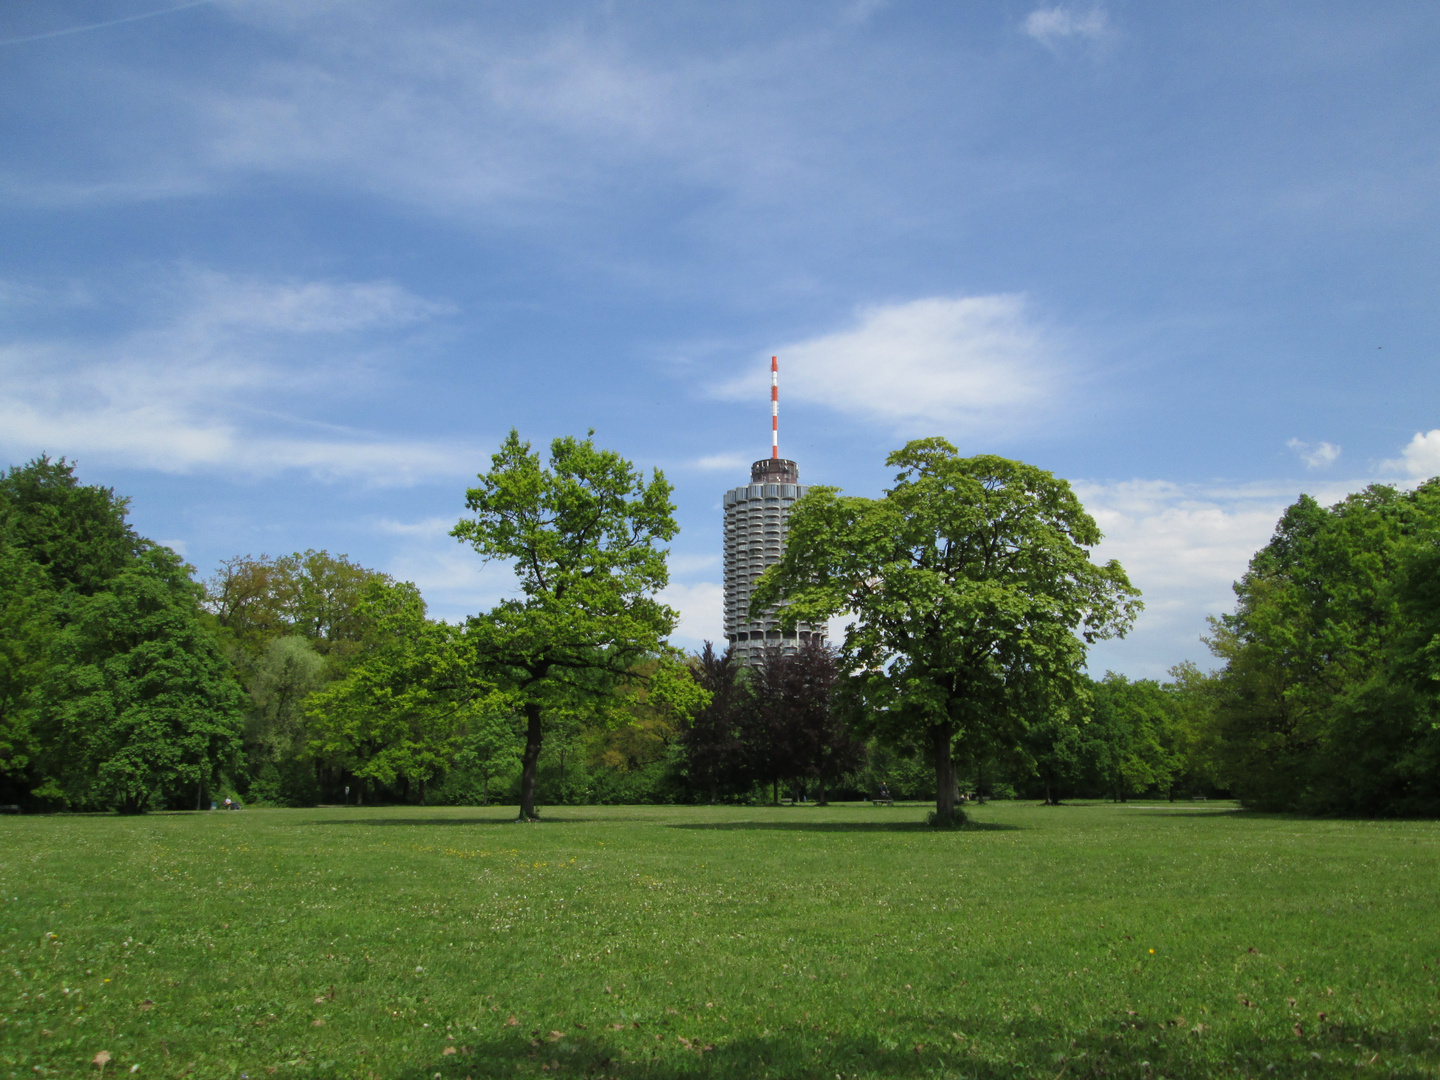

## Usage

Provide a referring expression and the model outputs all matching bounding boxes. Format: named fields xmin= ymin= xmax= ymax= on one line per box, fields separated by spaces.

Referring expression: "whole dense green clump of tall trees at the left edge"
xmin=0 ymin=458 xmax=240 ymax=812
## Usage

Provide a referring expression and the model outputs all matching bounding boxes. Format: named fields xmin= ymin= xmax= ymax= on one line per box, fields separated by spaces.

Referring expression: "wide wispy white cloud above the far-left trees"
xmin=0 ymin=272 xmax=475 ymax=484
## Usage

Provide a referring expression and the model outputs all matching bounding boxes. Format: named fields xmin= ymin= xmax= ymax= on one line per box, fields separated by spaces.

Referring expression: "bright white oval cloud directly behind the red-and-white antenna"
xmin=717 ymin=294 xmax=1070 ymax=431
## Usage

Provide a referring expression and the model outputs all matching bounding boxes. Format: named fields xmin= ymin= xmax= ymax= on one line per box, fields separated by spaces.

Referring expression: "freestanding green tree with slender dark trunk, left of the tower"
xmin=452 ymin=431 xmax=694 ymax=819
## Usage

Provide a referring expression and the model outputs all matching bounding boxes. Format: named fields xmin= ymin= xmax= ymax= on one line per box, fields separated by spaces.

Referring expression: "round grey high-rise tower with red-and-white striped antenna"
xmin=724 ymin=356 xmax=825 ymax=662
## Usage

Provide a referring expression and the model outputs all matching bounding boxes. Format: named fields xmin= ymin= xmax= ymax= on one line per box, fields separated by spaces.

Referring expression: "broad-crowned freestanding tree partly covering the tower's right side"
xmin=752 ymin=438 xmax=1139 ymax=822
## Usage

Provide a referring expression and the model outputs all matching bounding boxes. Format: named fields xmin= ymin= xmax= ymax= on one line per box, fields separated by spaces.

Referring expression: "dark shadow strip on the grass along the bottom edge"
xmin=392 ymin=1014 xmax=1437 ymax=1080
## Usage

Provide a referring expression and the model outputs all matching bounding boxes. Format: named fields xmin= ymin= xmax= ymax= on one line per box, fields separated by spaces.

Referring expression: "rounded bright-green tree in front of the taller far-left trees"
xmin=27 ymin=547 xmax=242 ymax=812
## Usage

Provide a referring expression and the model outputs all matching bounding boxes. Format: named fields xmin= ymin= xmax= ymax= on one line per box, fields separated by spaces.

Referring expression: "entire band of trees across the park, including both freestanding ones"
xmin=0 ymin=431 xmax=1440 ymax=827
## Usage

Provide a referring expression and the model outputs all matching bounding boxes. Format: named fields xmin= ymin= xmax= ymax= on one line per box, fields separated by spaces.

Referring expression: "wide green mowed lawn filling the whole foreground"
xmin=0 ymin=804 xmax=1440 ymax=1080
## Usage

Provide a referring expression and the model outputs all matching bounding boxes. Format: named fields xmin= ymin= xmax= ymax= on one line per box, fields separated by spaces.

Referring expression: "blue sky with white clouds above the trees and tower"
xmin=0 ymin=0 xmax=1440 ymax=675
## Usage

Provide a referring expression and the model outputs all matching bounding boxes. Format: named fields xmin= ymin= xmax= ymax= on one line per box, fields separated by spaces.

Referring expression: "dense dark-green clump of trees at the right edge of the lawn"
xmin=1210 ymin=481 xmax=1440 ymax=814
